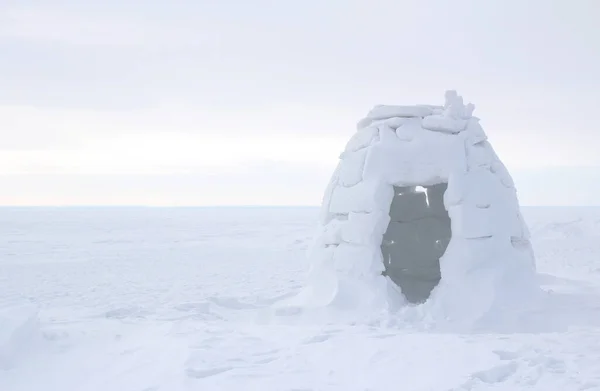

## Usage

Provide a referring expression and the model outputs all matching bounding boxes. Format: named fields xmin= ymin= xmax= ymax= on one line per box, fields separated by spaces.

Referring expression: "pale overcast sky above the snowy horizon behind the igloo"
xmin=0 ymin=0 xmax=600 ymax=206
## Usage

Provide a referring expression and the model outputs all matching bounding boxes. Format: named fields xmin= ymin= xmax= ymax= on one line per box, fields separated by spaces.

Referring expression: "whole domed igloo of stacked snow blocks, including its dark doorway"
xmin=294 ymin=91 xmax=535 ymax=324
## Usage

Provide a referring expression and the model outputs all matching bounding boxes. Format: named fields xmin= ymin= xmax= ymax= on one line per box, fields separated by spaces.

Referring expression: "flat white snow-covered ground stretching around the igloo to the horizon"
xmin=0 ymin=208 xmax=600 ymax=391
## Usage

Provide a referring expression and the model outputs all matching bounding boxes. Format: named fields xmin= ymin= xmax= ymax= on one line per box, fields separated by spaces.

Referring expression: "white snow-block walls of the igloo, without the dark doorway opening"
xmin=279 ymin=91 xmax=540 ymax=329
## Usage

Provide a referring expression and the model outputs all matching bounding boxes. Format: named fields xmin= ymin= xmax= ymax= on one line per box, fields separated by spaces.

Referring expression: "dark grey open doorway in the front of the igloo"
xmin=381 ymin=183 xmax=452 ymax=303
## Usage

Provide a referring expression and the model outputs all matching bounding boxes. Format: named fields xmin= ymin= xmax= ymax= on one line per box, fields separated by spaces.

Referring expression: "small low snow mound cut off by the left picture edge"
xmin=0 ymin=305 xmax=39 ymax=370
